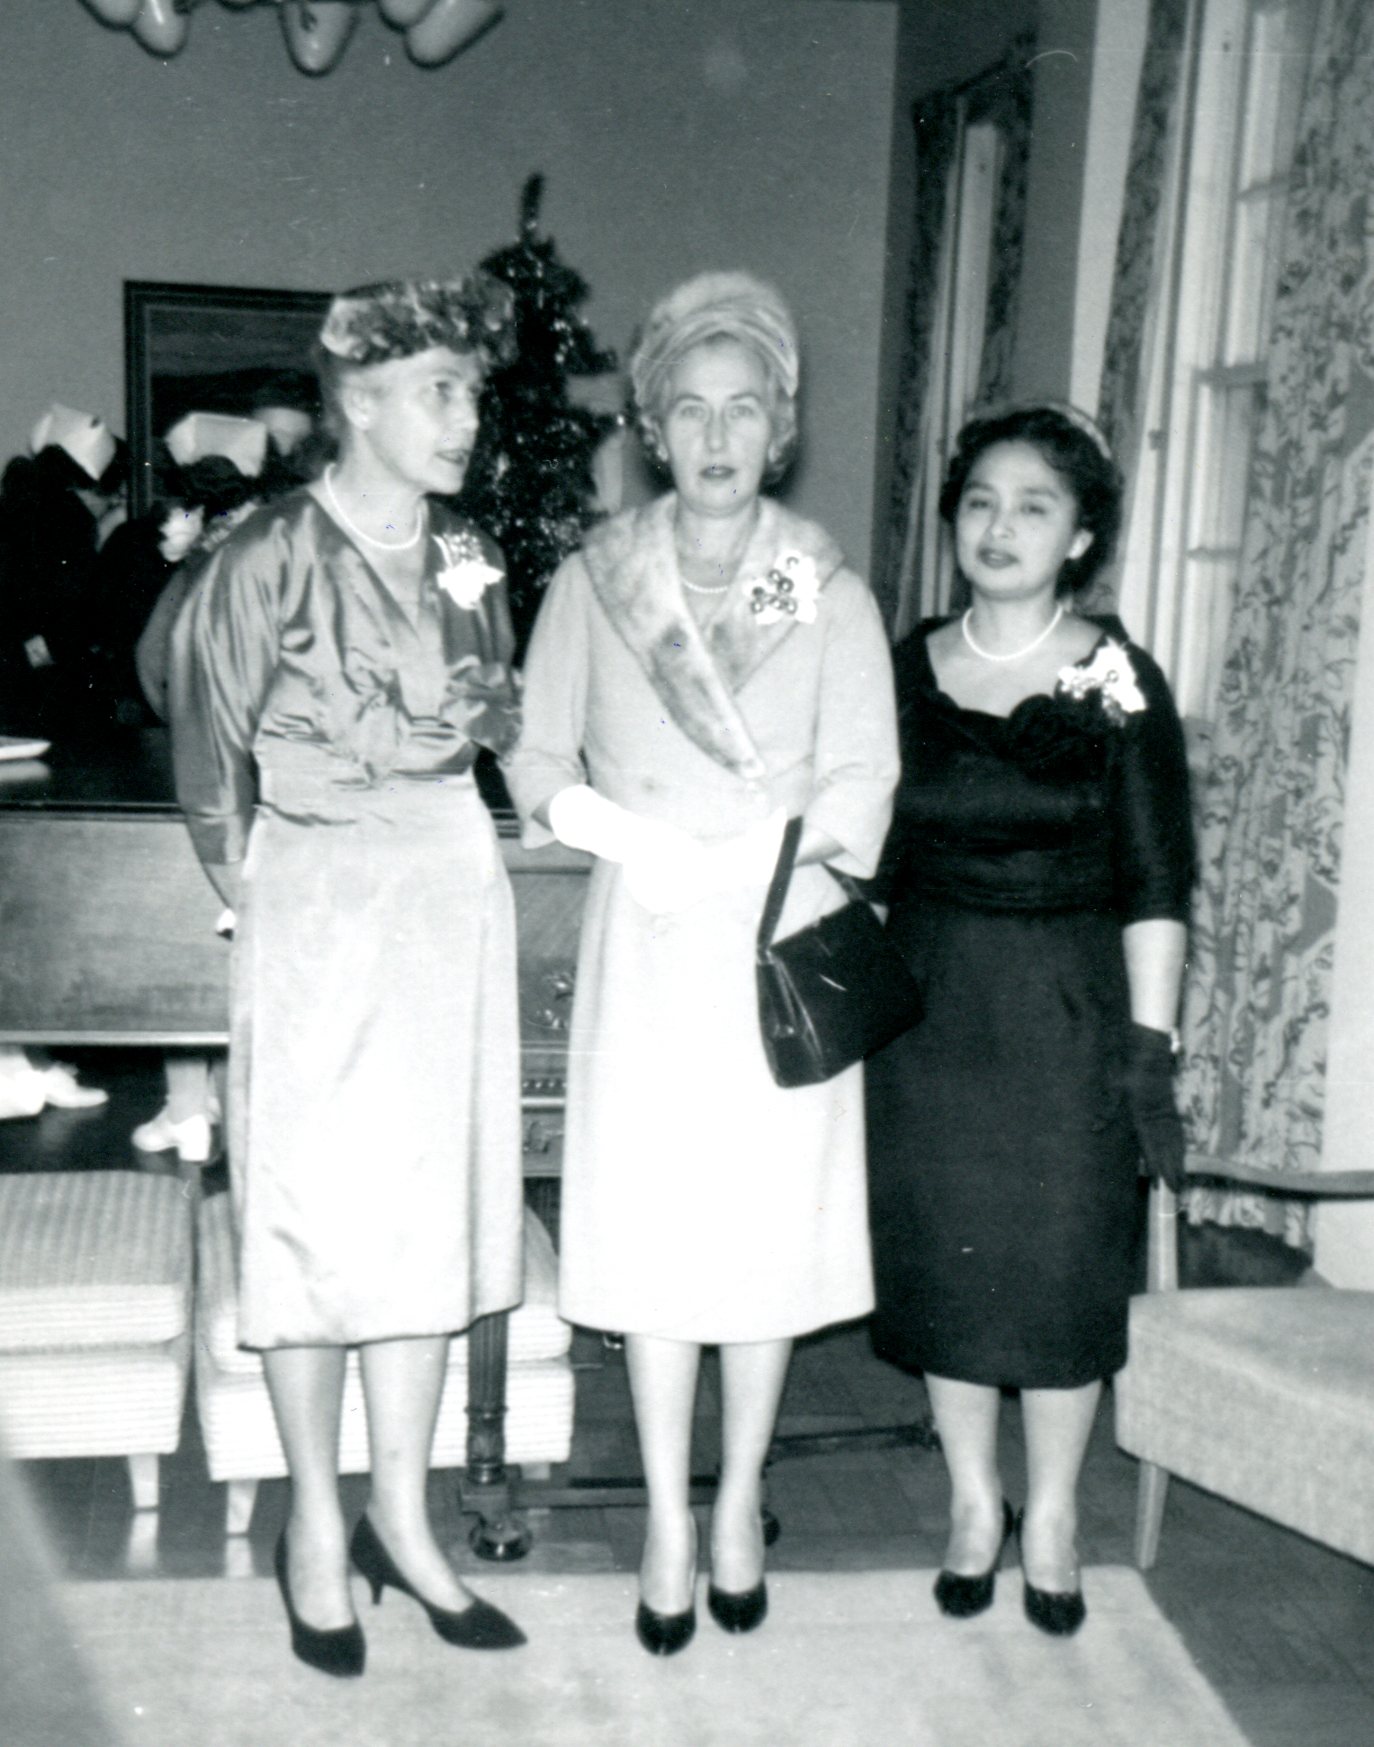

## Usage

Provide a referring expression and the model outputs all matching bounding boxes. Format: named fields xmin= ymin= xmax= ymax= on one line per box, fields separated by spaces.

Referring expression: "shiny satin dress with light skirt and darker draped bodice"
xmin=170 ymin=491 xmax=521 ymax=1347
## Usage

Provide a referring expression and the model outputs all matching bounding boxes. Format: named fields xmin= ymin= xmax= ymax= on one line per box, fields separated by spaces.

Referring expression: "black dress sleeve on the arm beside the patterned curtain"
xmin=1110 ymin=645 xmax=1196 ymax=922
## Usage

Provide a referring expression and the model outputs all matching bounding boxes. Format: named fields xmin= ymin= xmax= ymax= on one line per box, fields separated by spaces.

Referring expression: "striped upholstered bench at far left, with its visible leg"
xmin=0 ymin=1170 xmax=192 ymax=1509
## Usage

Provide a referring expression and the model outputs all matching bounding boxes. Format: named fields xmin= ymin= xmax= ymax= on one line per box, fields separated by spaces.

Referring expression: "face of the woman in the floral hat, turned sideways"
xmin=343 ymin=346 xmax=482 ymax=496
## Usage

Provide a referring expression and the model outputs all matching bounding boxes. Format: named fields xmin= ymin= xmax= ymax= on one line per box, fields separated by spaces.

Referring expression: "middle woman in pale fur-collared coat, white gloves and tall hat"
xmin=507 ymin=273 xmax=897 ymax=1654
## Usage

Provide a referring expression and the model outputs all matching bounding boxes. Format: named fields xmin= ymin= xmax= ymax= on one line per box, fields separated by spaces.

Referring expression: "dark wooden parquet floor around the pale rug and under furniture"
xmin=0 ymin=1052 xmax=1374 ymax=1747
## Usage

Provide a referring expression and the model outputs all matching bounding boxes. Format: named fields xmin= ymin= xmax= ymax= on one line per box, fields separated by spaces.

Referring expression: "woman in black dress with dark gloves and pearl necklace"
xmin=867 ymin=405 xmax=1192 ymax=1633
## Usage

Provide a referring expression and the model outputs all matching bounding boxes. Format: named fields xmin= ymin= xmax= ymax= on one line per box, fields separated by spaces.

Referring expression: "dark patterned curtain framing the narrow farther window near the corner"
xmin=876 ymin=33 xmax=1035 ymax=622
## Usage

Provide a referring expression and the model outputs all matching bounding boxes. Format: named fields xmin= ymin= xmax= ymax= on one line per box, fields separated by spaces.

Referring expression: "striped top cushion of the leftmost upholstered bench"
xmin=0 ymin=1170 xmax=191 ymax=1352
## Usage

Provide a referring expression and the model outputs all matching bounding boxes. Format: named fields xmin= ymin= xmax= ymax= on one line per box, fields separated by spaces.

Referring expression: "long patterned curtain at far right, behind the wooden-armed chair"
xmin=1183 ymin=0 xmax=1374 ymax=1244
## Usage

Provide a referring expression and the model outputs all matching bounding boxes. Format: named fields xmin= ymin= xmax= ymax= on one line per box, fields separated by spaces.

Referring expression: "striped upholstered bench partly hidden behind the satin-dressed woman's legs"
xmin=196 ymin=1195 xmax=573 ymax=1534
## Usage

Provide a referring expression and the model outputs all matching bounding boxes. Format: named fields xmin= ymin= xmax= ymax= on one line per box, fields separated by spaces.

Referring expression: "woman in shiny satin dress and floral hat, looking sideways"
xmin=171 ymin=276 xmax=523 ymax=1675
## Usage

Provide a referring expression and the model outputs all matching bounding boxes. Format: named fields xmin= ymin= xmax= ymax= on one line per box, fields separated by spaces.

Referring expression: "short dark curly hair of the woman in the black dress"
xmin=940 ymin=405 xmax=1124 ymax=596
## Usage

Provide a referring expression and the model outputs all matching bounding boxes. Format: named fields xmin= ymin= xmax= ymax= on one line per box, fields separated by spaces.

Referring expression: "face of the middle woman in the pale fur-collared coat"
xmin=659 ymin=339 xmax=773 ymax=515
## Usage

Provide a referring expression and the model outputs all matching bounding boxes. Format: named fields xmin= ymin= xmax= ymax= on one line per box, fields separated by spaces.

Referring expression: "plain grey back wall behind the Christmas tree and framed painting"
xmin=0 ymin=0 xmax=895 ymax=561
